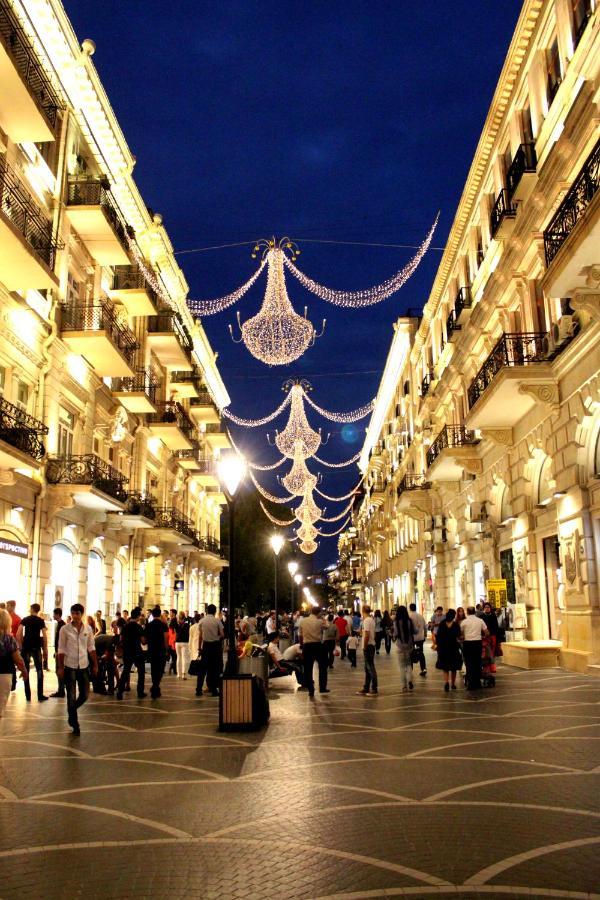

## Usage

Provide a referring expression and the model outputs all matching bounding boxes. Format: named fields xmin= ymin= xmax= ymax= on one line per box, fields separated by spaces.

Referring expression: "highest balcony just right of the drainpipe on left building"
xmin=66 ymin=175 xmax=129 ymax=266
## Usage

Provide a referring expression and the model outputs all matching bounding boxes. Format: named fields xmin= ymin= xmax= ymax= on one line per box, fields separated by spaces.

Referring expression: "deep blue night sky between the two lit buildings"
xmin=65 ymin=0 xmax=521 ymax=564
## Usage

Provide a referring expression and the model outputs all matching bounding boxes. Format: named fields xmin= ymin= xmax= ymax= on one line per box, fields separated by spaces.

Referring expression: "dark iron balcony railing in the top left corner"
xmin=0 ymin=0 xmax=63 ymax=130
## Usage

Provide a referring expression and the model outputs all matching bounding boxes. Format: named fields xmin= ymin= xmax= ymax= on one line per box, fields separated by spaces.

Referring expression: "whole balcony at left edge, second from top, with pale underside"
xmin=0 ymin=157 xmax=64 ymax=291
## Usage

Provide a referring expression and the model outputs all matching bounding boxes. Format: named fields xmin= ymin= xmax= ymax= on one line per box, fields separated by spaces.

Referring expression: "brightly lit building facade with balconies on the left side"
xmin=0 ymin=0 xmax=229 ymax=615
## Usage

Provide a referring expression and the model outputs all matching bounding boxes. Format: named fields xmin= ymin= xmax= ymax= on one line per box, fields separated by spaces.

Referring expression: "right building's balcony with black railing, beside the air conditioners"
xmin=466 ymin=332 xmax=558 ymax=428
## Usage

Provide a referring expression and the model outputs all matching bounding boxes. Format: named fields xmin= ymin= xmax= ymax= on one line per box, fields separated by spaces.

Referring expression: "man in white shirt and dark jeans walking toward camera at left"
xmin=56 ymin=603 xmax=98 ymax=737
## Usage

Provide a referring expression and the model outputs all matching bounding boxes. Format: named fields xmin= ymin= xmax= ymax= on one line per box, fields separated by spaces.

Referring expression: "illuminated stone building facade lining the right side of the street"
xmin=340 ymin=0 xmax=600 ymax=671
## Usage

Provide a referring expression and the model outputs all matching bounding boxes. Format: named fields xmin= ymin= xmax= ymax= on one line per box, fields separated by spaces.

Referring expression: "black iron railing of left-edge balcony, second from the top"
xmin=0 ymin=157 xmax=64 ymax=269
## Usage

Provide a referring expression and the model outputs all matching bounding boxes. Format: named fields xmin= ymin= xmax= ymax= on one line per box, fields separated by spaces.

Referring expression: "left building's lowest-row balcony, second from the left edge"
xmin=46 ymin=453 xmax=128 ymax=512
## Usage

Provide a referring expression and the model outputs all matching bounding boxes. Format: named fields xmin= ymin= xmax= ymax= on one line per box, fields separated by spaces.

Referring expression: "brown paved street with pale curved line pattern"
xmin=0 ymin=653 xmax=600 ymax=900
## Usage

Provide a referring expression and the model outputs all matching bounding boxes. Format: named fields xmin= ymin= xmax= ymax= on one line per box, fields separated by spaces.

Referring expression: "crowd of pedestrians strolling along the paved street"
xmin=0 ymin=601 xmax=504 ymax=735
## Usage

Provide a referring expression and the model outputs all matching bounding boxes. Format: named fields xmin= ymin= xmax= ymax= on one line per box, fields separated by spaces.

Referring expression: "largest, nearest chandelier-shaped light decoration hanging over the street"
xmin=229 ymin=238 xmax=325 ymax=366
